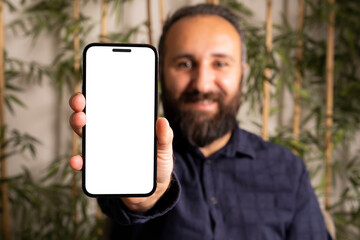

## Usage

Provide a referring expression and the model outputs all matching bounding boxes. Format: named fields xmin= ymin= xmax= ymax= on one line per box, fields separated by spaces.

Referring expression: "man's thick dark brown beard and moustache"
xmin=162 ymin=84 xmax=242 ymax=147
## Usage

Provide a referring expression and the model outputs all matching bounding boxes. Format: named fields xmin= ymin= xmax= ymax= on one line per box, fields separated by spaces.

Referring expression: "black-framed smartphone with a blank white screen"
xmin=82 ymin=43 xmax=158 ymax=197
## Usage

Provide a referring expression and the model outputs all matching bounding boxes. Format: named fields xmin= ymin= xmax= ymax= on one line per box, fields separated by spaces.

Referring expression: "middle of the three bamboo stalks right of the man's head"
xmin=293 ymin=0 xmax=305 ymax=152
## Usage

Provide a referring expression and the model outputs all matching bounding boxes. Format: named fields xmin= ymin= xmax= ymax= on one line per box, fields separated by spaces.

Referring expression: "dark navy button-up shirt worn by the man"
xmin=98 ymin=128 xmax=331 ymax=240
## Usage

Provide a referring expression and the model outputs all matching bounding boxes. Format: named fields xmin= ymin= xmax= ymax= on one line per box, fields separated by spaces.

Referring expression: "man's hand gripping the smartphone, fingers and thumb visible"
xmin=69 ymin=93 xmax=173 ymax=212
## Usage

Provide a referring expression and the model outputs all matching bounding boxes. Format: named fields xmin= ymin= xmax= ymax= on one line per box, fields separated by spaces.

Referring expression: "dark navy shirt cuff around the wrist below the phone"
xmin=97 ymin=173 xmax=181 ymax=225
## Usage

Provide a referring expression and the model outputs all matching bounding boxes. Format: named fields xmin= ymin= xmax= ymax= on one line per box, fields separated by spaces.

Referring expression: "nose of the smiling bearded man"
xmin=191 ymin=63 xmax=215 ymax=93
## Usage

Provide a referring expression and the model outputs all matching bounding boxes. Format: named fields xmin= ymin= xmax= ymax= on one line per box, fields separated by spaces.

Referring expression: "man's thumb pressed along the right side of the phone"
xmin=156 ymin=118 xmax=173 ymax=183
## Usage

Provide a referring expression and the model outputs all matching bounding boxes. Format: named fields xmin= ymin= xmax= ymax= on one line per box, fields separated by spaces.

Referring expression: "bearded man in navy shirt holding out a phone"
xmin=70 ymin=4 xmax=331 ymax=240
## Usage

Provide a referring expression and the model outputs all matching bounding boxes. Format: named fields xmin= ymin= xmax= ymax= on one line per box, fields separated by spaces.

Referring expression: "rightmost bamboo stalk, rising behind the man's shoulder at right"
xmin=325 ymin=0 xmax=335 ymax=209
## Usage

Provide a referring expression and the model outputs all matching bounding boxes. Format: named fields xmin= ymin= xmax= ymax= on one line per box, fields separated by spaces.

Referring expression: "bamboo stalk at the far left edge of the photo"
xmin=0 ymin=1 xmax=11 ymax=240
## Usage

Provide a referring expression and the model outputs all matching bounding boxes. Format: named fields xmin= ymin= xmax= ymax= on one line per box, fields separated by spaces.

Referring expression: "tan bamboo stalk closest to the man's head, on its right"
xmin=261 ymin=0 xmax=272 ymax=140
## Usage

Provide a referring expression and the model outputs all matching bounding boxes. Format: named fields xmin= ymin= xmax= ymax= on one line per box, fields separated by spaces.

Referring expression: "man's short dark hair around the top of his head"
xmin=159 ymin=4 xmax=247 ymax=75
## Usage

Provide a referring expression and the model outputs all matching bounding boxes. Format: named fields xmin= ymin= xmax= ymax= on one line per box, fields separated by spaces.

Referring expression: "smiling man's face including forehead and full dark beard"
xmin=162 ymin=15 xmax=242 ymax=147
